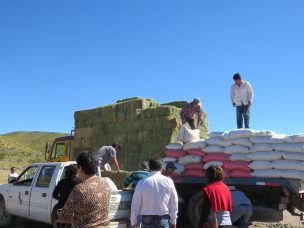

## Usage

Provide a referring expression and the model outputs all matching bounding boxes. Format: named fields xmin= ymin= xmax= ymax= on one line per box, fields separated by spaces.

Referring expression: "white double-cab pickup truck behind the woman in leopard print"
xmin=0 ymin=162 xmax=132 ymax=227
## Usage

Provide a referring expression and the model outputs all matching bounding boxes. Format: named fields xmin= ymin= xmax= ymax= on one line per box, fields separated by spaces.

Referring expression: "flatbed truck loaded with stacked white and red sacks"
xmin=164 ymin=129 xmax=304 ymax=224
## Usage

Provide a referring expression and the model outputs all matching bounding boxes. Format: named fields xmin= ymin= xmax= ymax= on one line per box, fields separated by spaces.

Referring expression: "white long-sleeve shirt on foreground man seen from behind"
xmin=130 ymin=172 xmax=178 ymax=225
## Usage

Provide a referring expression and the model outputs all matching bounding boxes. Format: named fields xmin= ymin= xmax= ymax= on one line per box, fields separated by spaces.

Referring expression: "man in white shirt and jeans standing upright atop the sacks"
xmin=230 ymin=73 xmax=253 ymax=128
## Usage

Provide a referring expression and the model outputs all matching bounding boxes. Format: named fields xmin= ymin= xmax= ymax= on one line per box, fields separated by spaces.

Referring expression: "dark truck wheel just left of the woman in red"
xmin=187 ymin=191 xmax=203 ymax=228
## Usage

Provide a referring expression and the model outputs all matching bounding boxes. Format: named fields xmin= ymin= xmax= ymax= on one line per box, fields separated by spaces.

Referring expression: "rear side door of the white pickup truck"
xmin=30 ymin=165 xmax=56 ymax=223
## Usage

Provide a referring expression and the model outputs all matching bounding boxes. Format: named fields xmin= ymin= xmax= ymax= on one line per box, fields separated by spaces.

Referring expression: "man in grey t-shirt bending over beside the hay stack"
xmin=97 ymin=143 xmax=122 ymax=172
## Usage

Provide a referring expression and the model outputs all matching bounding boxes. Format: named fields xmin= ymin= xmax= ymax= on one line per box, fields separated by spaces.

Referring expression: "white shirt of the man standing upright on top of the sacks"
xmin=230 ymin=81 xmax=253 ymax=106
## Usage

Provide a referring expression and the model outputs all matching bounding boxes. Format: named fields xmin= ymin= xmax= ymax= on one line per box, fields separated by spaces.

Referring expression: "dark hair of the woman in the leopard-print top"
xmin=77 ymin=151 xmax=99 ymax=175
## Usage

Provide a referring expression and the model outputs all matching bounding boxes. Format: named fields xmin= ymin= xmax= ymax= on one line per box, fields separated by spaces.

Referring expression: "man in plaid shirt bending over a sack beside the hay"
xmin=180 ymin=98 xmax=202 ymax=130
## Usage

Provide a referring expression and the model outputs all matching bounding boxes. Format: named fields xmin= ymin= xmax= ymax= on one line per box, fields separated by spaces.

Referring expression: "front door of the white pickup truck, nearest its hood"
xmin=7 ymin=166 xmax=38 ymax=217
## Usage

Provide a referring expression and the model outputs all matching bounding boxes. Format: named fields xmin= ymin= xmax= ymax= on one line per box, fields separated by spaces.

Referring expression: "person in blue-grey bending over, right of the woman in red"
xmin=229 ymin=186 xmax=252 ymax=228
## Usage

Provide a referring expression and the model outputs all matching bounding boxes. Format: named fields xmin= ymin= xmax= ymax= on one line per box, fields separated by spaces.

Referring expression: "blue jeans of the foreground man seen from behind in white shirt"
xmin=141 ymin=215 xmax=170 ymax=228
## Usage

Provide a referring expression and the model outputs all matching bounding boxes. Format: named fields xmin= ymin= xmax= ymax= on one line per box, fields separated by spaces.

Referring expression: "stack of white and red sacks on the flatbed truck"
xmin=164 ymin=129 xmax=304 ymax=180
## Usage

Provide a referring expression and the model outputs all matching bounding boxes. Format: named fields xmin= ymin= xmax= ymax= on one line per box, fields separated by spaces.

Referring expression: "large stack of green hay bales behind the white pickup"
xmin=74 ymin=97 xmax=208 ymax=170
